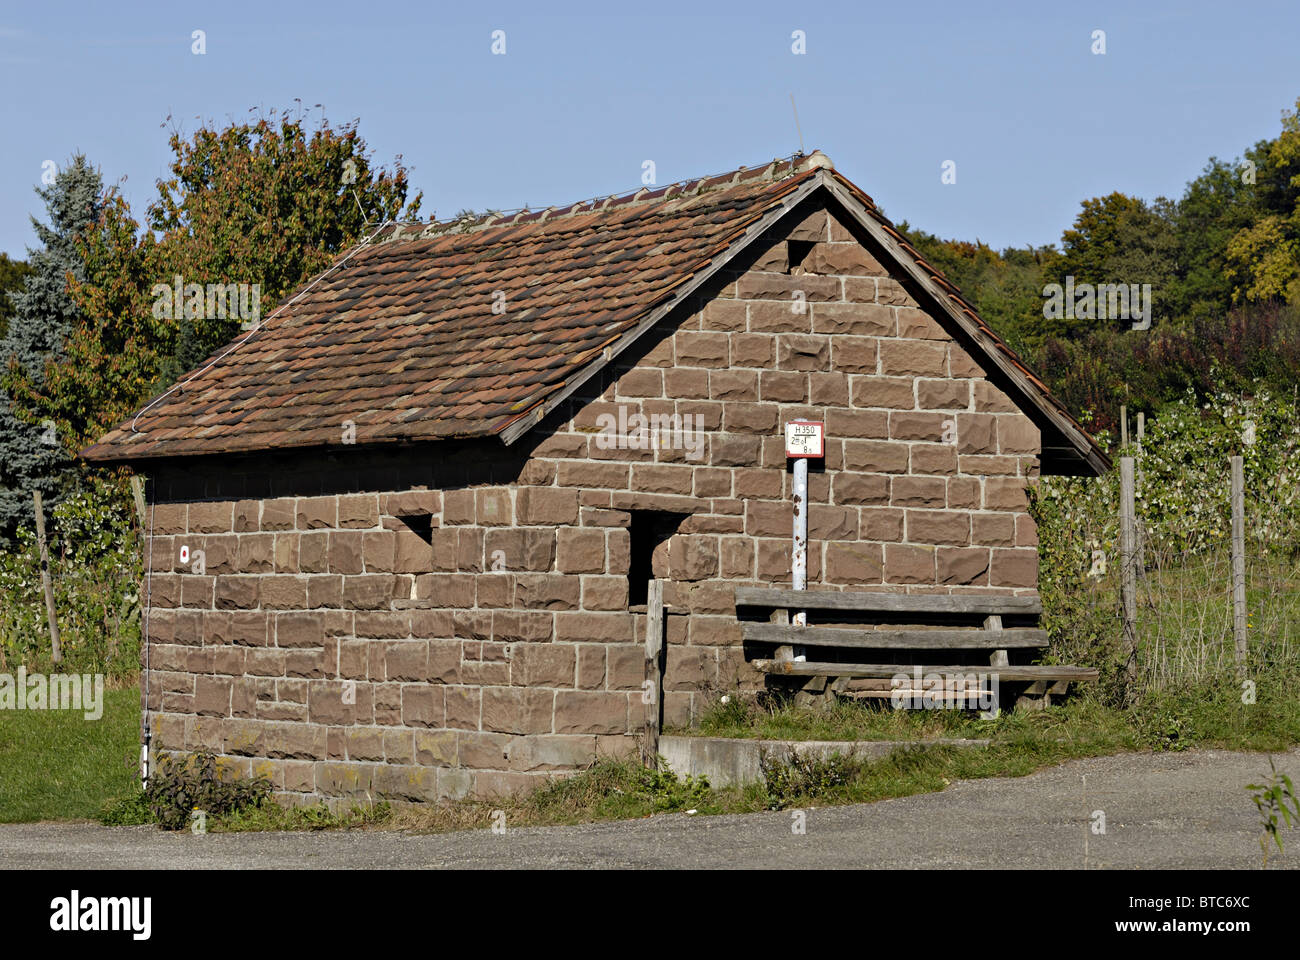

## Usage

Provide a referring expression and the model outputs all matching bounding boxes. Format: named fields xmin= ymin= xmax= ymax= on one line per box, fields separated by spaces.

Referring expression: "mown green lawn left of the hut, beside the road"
xmin=0 ymin=687 xmax=140 ymax=823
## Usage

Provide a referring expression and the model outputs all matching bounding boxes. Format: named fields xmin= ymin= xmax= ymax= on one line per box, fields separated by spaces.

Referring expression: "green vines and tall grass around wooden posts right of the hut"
xmin=1031 ymin=393 xmax=1300 ymax=704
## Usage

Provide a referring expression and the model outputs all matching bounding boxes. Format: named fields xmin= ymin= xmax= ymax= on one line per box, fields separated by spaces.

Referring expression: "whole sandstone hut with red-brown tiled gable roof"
xmin=82 ymin=152 xmax=1108 ymax=800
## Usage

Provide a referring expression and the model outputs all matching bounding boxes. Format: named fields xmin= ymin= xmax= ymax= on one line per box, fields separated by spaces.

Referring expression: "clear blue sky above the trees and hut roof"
xmin=0 ymin=0 xmax=1300 ymax=256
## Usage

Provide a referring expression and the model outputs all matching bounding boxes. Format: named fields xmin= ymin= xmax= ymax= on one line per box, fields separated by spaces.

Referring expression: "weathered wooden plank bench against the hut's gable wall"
xmin=736 ymin=587 xmax=1097 ymax=715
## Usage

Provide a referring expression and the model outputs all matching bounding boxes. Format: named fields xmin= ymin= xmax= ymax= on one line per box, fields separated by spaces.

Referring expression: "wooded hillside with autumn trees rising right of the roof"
xmin=901 ymin=93 xmax=1300 ymax=429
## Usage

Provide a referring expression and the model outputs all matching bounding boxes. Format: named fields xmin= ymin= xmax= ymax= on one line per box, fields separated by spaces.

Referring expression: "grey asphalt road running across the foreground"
xmin=0 ymin=751 xmax=1300 ymax=869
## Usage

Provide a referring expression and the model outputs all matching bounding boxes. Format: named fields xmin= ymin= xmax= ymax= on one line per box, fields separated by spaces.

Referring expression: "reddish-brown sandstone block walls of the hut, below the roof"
xmin=137 ymin=197 xmax=1040 ymax=800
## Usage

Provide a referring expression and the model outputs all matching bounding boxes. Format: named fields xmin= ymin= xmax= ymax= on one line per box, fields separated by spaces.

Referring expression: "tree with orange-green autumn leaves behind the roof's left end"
xmin=5 ymin=112 xmax=421 ymax=450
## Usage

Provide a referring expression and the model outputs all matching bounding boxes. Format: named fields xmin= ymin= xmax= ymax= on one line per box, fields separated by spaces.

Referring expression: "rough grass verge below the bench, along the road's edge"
xmin=366 ymin=675 xmax=1300 ymax=833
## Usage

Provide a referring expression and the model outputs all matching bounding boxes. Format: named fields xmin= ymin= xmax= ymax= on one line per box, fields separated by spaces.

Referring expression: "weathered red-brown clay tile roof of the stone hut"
xmin=82 ymin=152 xmax=1104 ymax=476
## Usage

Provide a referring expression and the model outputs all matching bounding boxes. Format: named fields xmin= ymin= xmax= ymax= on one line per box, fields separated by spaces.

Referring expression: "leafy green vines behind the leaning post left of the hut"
xmin=0 ymin=473 xmax=143 ymax=676
